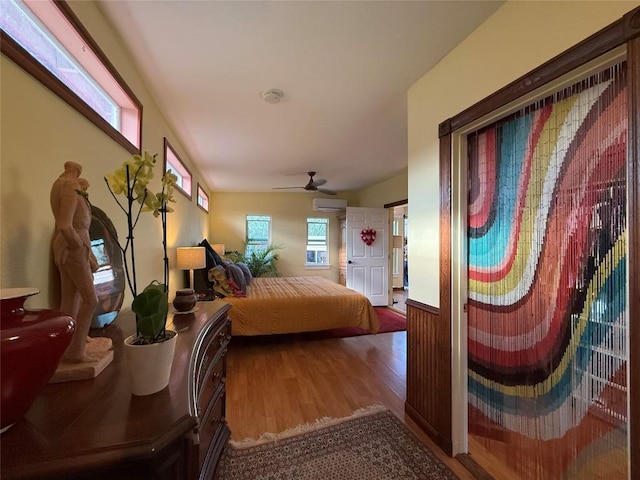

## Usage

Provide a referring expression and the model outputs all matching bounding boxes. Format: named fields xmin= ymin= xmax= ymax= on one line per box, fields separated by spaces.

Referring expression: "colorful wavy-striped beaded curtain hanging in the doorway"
xmin=468 ymin=63 xmax=628 ymax=480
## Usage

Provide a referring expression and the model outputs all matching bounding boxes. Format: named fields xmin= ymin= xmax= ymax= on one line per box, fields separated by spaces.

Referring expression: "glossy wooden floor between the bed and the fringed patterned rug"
xmin=227 ymin=332 xmax=474 ymax=480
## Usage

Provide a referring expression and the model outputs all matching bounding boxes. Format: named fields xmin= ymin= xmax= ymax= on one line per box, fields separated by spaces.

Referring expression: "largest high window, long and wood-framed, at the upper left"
xmin=0 ymin=0 xmax=142 ymax=153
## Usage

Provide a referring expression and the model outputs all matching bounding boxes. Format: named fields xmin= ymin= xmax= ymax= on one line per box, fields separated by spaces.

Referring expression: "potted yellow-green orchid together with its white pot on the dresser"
xmin=105 ymin=152 xmax=177 ymax=395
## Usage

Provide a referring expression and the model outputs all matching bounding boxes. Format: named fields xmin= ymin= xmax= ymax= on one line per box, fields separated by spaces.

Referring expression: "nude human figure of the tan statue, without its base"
xmin=50 ymin=162 xmax=98 ymax=363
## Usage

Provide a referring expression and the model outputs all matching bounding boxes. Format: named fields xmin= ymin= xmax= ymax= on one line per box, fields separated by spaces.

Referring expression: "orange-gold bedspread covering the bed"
xmin=224 ymin=277 xmax=379 ymax=335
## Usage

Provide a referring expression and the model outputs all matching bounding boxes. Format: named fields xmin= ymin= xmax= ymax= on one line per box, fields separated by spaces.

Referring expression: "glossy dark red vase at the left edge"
xmin=0 ymin=288 xmax=75 ymax=433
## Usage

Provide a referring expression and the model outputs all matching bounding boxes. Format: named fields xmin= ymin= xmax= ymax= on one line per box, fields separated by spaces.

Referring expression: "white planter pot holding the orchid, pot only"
xmin=124 ymin=330 xmax=178 ymax=396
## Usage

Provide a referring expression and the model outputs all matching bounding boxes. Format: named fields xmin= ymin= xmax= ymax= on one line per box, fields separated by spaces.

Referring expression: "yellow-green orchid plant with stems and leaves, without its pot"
xmin=104 ymin=151 xmax=177 ymax=344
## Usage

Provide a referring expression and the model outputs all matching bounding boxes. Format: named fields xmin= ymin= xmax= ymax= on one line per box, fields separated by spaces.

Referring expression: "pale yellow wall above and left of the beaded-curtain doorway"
xmin=407 ymin=1 xmax=639 ymax=307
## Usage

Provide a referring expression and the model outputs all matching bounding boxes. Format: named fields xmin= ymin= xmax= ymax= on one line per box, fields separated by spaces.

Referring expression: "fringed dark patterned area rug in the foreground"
xmin=215 ymin=406 xmax=458 ymax=480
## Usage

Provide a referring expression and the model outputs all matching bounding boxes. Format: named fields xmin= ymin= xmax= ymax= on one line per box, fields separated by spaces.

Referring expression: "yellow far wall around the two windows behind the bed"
xmin=209 ymin=192 xmax=355 ymax=282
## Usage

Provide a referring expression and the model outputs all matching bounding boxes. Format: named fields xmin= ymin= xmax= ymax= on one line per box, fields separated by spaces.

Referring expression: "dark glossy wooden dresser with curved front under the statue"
xmin=0 ymin=300 xmax=231 ymax=480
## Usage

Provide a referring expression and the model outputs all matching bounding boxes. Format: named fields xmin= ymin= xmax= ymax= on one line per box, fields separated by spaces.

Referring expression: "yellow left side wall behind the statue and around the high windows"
xmin=0 ymin=1 xmax=208 ymax=308
